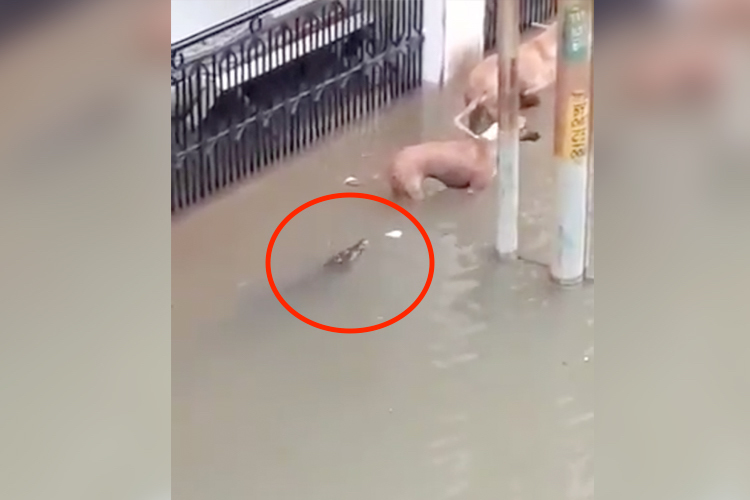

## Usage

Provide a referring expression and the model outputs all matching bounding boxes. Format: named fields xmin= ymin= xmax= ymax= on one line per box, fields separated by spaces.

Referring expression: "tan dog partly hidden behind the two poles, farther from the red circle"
xmin=464 ymin=22 xmax=557 ymax=131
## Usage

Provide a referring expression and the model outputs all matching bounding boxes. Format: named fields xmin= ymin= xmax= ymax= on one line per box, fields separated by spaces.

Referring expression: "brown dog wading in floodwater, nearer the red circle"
xmin=388 ymin=117 xmax=539 ymax=200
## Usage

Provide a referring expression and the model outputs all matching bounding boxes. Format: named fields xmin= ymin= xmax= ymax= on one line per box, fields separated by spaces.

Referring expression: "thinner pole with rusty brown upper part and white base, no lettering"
xmin=495 ymin=0 xmax=520 ymax=259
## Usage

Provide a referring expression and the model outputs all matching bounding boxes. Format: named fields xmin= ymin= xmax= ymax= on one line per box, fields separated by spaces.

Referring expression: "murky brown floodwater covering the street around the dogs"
xmin=172 ymin=84 xmax=594 ymax=500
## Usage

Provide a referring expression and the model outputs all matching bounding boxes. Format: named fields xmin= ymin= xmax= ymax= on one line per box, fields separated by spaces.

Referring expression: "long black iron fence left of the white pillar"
xmin=171 ymin=0 xmax=424 ymax=212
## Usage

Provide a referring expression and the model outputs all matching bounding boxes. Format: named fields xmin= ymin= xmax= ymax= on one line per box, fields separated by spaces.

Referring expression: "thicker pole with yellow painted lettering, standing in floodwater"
xmin=551 ymin=0 xmax=593 ymax=285
